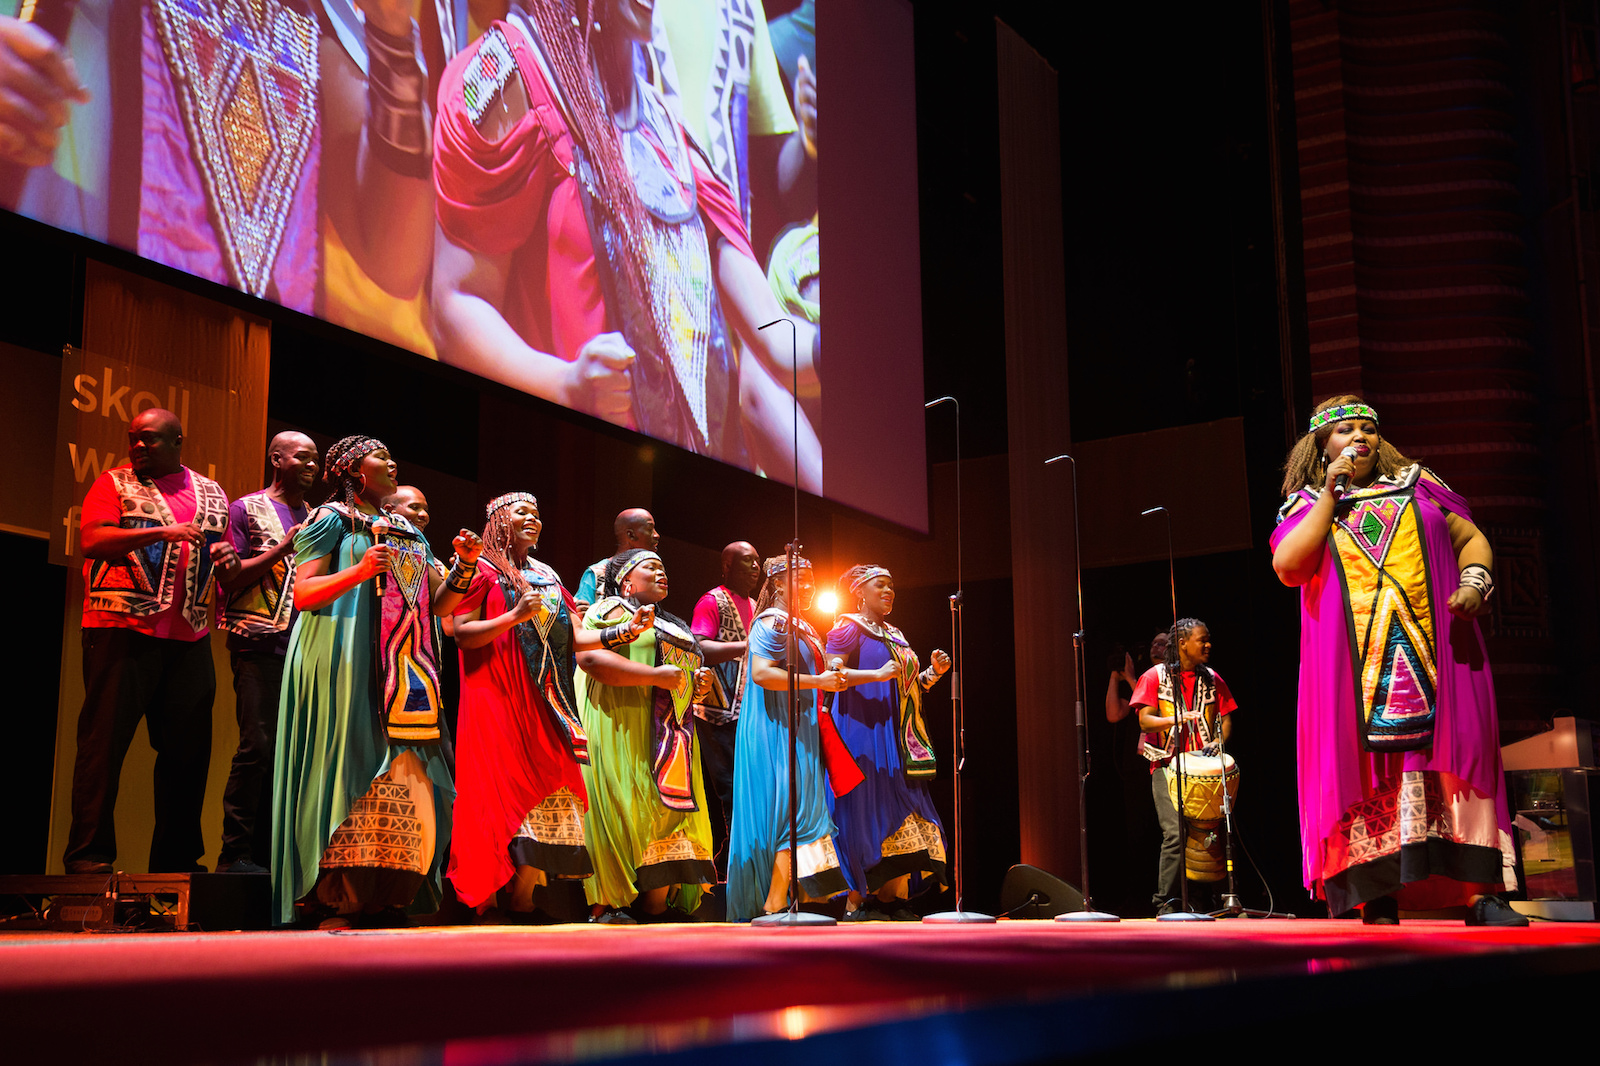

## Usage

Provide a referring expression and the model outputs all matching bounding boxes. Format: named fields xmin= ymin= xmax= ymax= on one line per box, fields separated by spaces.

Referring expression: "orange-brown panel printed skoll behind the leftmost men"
xmin=45 ymin=261 xmax=270 ymax=874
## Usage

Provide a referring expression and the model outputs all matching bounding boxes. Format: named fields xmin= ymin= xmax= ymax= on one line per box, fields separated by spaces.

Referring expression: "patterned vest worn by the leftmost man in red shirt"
xmin=83 ymin=466 xmax=227 ymax=632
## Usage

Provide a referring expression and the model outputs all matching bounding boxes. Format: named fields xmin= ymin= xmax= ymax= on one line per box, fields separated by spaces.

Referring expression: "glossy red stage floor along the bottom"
xmin=0 ymin=919 xmax=1600 ymax=1066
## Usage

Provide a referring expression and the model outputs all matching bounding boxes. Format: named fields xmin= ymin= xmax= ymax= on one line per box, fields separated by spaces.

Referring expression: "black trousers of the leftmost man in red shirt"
xmin=66 ymin=629 xmax=216 ymax=874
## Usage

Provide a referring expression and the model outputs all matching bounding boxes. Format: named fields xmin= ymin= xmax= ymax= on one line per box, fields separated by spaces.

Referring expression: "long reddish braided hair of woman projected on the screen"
xmin=520 ymin=0 xmax=670 ymax=384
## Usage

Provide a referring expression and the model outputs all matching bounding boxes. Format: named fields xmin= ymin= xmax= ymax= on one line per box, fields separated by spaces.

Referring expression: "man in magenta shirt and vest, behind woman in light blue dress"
xmin=690 ymin=541 xmax=762 ymax=877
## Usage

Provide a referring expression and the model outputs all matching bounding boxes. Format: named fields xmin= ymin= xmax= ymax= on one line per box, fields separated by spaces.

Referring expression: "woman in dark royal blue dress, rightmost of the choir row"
xmin=827 ymin=567 xmax=949 ymax=901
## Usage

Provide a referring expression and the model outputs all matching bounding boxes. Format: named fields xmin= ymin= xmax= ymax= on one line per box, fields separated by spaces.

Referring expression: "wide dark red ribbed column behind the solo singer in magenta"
xmin=1288 ymin=0 xmax=1555 ymax=736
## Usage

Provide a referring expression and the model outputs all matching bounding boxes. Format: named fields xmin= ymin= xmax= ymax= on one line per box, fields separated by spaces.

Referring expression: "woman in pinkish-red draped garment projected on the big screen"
xmin=434 ymin=0 xmax=821 ymax=491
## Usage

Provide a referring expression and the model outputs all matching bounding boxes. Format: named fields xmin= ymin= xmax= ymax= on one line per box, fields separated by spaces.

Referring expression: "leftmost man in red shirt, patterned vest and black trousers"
xmin=66 ymin=408 xmax=238 ymax=874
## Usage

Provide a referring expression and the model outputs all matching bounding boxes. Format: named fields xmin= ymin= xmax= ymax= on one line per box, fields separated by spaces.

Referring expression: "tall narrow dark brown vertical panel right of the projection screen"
xmin=995 ymin=22 xmax=1080 ymax=880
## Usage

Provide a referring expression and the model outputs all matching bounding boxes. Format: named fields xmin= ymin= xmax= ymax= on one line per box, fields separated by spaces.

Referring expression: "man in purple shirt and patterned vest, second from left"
xmin=216 ymin=431 xmax=318 ymax=874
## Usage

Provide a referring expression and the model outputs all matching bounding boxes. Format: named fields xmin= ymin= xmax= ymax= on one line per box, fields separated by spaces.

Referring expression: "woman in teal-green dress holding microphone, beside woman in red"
xmin=272 ymin=437 xmax=460 ymax=924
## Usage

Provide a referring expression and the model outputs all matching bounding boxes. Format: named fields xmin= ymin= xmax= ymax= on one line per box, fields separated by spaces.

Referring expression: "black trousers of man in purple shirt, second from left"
xmin=218 ymin=651 xmax=283 ymax=869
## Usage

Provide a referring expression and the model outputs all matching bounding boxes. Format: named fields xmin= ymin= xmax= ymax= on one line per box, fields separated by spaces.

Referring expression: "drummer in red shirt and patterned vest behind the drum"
xmin=1128 ymin=618 xmax=1235 ymax=914
